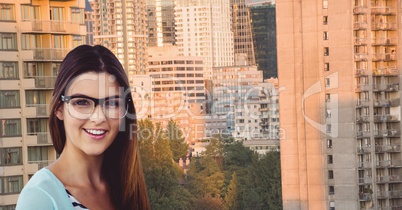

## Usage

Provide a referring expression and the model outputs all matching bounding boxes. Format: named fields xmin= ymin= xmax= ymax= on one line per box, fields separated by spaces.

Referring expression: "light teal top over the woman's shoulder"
xmin=16 ymin=168 xmax=74 ymax=210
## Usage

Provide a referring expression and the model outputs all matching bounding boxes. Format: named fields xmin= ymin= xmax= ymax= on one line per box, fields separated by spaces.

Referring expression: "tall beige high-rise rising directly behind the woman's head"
xmin=90 ymin=0 xmax=148 ymax=78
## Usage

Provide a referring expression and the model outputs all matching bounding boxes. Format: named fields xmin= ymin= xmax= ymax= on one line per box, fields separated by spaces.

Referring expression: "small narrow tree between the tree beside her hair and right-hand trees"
xmin=166 ymin=120 xmax=188 ymax=162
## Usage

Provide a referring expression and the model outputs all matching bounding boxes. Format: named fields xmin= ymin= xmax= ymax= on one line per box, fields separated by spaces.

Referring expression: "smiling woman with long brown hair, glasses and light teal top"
xmin=17 ymin=45 xmax=150 ymax=209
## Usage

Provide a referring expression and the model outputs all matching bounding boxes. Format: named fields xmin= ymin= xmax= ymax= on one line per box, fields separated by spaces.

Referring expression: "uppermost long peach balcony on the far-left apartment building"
xmin=21 ymin=20 xmax=80 ymax=34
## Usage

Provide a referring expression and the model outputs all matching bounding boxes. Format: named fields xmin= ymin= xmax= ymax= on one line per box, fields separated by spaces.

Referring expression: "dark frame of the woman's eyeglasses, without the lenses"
xmin=60 ymin=95 xmax=131 ymax=120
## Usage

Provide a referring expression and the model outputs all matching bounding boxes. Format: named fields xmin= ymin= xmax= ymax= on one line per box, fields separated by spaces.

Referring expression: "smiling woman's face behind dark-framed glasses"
xmin=56 ymin=72 xmax=125 ymax=156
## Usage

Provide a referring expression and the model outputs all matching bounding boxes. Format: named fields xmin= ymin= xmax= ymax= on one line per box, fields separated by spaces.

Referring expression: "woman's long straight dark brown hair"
xmin=49 ymin=45 xmax=150 ymax=209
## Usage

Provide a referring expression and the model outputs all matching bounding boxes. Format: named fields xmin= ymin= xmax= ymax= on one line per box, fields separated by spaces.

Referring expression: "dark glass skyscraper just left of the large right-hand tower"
xmin=250 ymin=1 xmax=278 ymax=79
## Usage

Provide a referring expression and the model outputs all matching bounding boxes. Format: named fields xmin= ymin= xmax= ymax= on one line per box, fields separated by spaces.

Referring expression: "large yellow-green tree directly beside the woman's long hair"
xmin=138 ymin=119 xmax=194 ymax=210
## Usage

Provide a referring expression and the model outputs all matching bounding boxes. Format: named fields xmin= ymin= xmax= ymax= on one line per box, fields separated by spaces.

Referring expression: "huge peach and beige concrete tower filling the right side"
xmin=276 ymin=0 xmax=402 ymax=210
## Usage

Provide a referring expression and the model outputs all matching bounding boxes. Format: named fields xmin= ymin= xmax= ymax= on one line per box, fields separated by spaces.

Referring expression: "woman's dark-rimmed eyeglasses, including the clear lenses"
xmin=61 ymin=95 xmax=130 ymax=120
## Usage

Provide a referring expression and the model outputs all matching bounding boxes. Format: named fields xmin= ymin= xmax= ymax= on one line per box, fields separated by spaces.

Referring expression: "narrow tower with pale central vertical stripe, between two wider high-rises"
xmin=147 ymin=0 xmax=175 ymax=47
